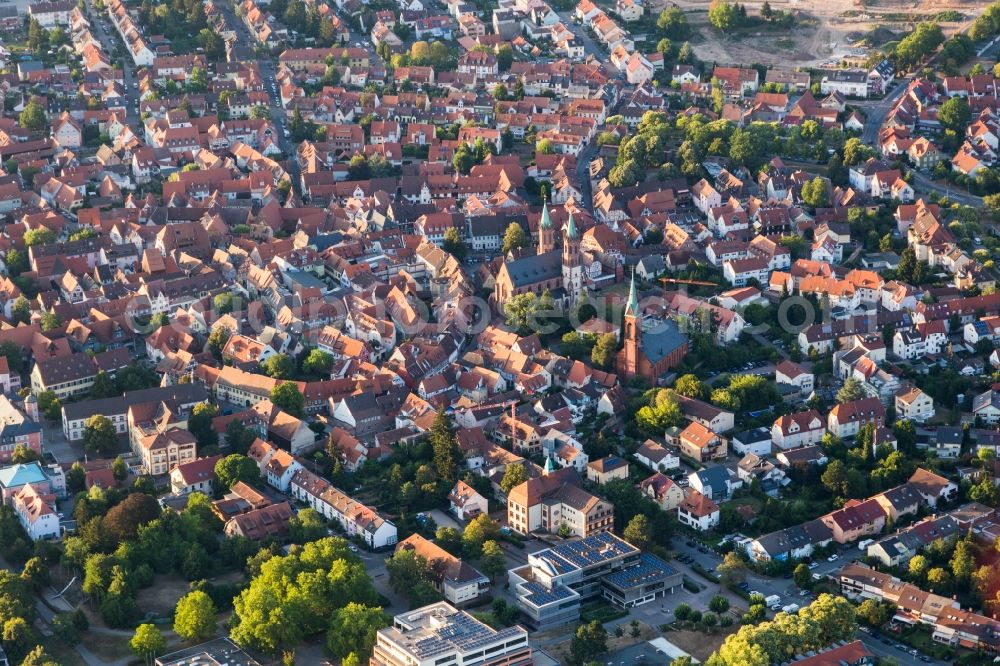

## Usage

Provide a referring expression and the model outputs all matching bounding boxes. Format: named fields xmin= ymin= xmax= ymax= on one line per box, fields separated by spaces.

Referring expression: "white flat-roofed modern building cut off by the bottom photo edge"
xmin=369 ymin=601 xmax=534 ymax=666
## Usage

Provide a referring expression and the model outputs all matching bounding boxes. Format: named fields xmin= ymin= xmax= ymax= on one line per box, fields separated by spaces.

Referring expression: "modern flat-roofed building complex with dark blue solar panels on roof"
xmin=509 ymin=532 xmax=683 ymax=630
